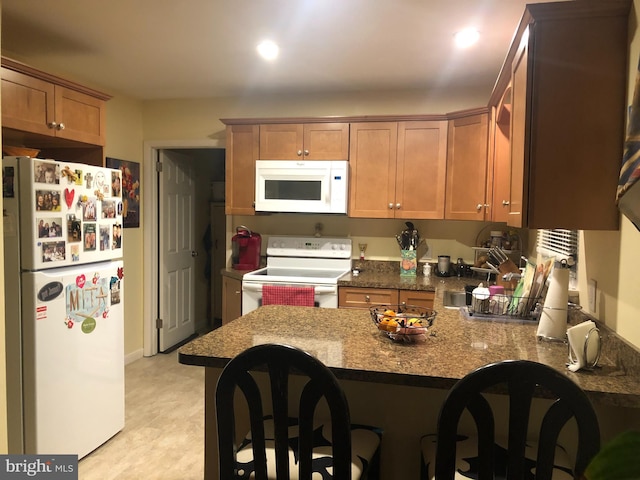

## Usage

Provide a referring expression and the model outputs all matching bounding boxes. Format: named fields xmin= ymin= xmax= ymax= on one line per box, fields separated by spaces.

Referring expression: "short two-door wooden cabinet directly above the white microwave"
xmin=260 ymin=123 xmax=349 ymax=160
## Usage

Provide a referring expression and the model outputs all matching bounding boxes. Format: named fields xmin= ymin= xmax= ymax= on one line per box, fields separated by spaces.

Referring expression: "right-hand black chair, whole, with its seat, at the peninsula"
xmin=421 ymin=360 xmax=600 ymax=480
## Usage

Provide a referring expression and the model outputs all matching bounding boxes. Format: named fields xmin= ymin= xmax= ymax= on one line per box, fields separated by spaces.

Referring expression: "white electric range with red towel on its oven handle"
xmin=242 ymin=236 xmax=352 ymax=315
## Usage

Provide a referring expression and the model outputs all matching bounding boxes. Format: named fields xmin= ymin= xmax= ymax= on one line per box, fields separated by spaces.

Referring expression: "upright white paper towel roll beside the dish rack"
xmin=536 ymin=268 xmax=569 ymax=341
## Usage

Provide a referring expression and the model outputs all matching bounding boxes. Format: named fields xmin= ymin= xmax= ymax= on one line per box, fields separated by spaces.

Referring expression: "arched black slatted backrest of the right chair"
xmin=435 ymin=360 xmax=600 ymax=480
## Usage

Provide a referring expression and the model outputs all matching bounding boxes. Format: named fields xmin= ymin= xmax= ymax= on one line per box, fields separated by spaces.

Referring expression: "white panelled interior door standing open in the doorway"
xmin=158 ymin=150 xmax=197 ymax=352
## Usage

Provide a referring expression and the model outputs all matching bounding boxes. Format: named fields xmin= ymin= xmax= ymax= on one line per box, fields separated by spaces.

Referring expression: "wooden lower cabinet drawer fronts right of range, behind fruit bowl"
xmin=338 ymin=287 xmax=435 ymax=309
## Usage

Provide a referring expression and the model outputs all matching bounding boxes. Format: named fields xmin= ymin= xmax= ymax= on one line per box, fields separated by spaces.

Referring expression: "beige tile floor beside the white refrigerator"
xmin=78 ymin=352 xmax=204 ymax=480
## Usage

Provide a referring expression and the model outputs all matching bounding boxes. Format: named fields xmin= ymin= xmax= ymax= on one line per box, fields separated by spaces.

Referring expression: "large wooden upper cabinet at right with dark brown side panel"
xmin=497 ymin=0 xmax=632 ymax=230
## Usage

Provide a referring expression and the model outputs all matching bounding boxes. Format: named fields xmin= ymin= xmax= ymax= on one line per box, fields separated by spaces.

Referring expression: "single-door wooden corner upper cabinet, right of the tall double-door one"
xmin=445 ymin=112 xmax=489 ymax=220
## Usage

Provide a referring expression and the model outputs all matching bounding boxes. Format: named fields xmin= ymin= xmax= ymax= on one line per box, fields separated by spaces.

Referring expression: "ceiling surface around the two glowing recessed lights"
xmin=1 ymin=0 xmax=564 ymax=99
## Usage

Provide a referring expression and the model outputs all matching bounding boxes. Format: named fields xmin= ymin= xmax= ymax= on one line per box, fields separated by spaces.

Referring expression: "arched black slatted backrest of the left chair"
xmin=215 ymin=344 xmax=351 ymax=480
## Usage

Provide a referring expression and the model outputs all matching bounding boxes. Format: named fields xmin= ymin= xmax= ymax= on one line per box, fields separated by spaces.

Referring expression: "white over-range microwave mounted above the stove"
xmin=255 ymin=160 xmax=349 ymax=214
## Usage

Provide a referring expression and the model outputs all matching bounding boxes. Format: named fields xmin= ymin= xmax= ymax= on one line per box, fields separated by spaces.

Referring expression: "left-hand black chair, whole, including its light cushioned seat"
xmin=215 ymin=344 xmax=382 ymax=480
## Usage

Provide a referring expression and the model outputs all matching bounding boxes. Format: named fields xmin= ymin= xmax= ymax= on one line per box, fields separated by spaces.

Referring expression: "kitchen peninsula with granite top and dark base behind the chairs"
xmin=179 ymin=277 xmax=640 ymax=479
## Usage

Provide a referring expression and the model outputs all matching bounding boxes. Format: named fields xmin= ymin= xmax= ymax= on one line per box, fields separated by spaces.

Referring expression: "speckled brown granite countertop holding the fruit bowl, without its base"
xmin=179 ymin=273 xmax=640 ymax=407
